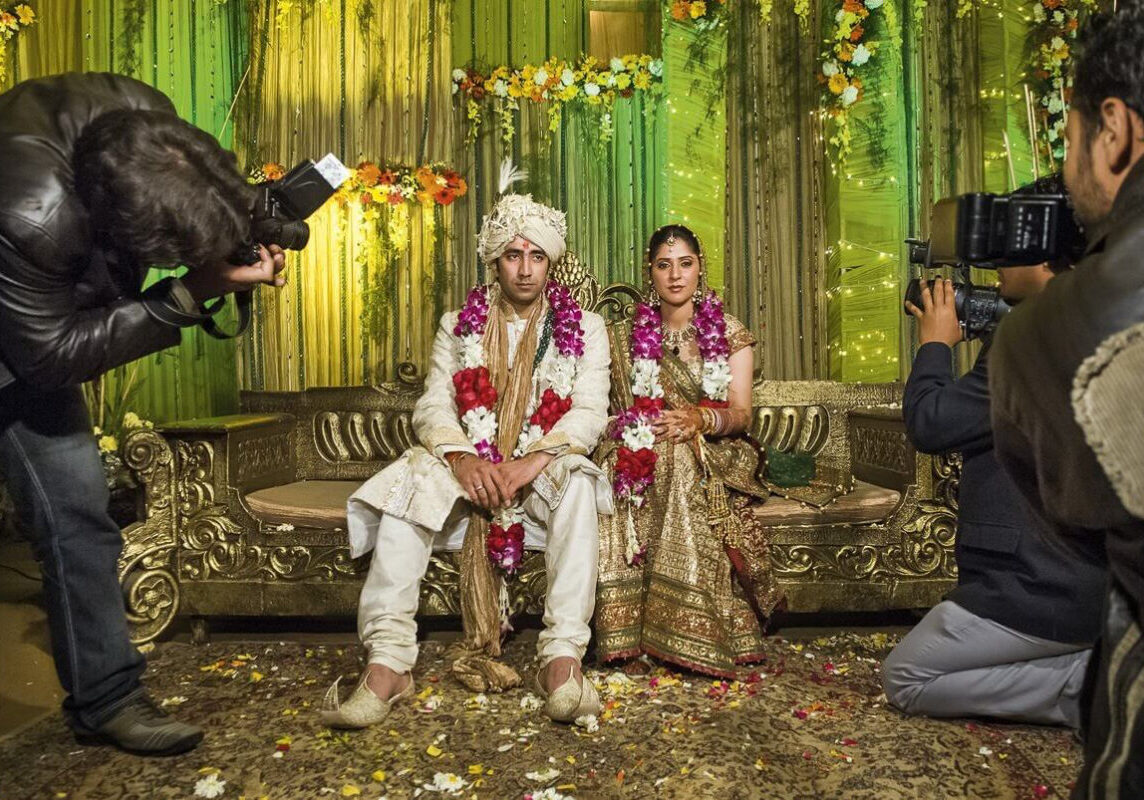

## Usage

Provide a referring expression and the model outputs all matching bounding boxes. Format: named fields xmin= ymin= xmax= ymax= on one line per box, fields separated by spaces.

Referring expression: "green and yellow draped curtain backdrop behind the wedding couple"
xmin=7 ymin=0 xmax=1107 ymax=409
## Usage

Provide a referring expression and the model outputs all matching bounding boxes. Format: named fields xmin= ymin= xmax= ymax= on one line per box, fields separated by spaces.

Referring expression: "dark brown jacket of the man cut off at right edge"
xmin=990 ymin=159 xmax=1144 ymax=619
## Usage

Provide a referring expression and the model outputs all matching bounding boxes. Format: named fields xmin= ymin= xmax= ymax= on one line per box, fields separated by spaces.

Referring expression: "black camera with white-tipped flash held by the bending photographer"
xmin=228 ymin=153 xmax=350 ymax=264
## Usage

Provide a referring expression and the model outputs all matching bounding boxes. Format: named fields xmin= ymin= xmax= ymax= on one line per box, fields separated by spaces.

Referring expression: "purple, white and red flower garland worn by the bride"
xmin=612 ymin=292 xmax=731 ymax=567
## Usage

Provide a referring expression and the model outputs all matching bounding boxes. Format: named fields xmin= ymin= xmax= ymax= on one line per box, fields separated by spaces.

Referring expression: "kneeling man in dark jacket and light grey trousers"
xmin=882 ymin=182 xmax=1107 ymax=728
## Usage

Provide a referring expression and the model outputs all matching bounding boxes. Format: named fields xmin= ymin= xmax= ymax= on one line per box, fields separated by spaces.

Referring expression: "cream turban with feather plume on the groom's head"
xmin=477 ymin=158 xmax=567 ymax=264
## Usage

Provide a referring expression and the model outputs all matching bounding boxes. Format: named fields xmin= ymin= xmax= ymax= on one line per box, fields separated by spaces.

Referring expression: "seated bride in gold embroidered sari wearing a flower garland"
xmin=596 ymin=224 xmax=780 ymax=676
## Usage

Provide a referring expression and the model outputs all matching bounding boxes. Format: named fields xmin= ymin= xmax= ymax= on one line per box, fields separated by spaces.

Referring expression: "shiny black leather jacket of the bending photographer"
xmin=0 ymin=73 xmax=180 ymax=389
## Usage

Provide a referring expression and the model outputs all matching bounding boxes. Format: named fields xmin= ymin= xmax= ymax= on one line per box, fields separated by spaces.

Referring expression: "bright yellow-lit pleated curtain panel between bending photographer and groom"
xmin=237 ymin=0 xmax=457 ymax=390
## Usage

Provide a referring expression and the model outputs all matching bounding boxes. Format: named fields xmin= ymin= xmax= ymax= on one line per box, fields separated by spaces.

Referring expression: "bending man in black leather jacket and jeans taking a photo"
xmin=0 ymin=74 xmax=285 ymax=754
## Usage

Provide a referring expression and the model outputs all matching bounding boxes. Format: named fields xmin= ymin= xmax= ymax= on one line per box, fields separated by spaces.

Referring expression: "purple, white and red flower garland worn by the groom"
xmin=453 ymin=282 xmax=583 ymax=573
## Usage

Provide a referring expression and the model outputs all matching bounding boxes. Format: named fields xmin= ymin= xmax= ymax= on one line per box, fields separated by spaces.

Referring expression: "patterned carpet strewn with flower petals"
xmin=0 ymin=634 xmax=1080 ymax=800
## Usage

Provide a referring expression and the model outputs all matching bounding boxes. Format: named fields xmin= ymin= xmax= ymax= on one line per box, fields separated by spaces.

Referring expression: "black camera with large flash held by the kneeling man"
xmin=905 ymin=175 xmax=1085 ymax=339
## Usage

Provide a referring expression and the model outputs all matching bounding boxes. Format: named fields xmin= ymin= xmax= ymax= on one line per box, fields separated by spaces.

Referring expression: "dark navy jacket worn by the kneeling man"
xmin=903 ymin=342 xmax=1107 ymax=644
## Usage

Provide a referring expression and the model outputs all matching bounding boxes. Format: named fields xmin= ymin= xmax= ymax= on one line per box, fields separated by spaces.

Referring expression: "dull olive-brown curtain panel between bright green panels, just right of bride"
xmin=724 ymin=2 xmax=829 ymax=380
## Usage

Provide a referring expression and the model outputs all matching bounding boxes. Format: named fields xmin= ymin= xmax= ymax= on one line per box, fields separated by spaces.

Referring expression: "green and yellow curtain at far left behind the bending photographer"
xmin=0 ymin=0 xmax=247 ymax=421
